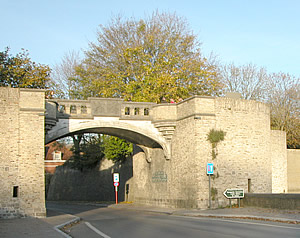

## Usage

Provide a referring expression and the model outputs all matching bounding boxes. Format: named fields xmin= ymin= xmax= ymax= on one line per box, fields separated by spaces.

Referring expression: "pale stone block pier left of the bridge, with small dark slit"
xmin=0 ymin=87 xmax=46 ymax=218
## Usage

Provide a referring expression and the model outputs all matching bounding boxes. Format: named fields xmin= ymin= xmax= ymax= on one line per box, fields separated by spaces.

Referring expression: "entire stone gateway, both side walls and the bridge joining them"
xmin=0 ymin=88 xmax=287 ymax=216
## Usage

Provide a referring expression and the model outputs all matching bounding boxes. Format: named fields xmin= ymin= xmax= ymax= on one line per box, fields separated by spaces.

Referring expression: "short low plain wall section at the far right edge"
xmin=287 ymin=150 xmax=300 ymax=193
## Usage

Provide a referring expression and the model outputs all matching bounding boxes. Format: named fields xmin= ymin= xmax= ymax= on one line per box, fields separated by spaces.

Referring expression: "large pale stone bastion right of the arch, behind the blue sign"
xmin=127 ymin=96 xmax=287 ymax=208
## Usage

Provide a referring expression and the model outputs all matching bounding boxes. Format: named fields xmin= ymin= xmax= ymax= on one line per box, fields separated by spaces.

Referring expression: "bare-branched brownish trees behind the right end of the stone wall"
xmin=220 ymin=64 xmax=300 ymax=148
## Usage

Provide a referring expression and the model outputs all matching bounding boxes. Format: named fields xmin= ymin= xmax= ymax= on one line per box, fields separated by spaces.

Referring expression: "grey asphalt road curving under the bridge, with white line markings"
xmin=51 ymin=204 xmax=300 ymax=238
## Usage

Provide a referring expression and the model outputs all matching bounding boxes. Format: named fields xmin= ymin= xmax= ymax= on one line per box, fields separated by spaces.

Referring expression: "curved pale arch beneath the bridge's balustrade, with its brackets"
xmin=45 ymin=118 xmax=171 ymax=162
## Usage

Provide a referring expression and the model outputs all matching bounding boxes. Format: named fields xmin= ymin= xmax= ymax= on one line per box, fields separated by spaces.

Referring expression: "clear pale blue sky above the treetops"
xmin=0 ymin=0 xmax=300 ymax=77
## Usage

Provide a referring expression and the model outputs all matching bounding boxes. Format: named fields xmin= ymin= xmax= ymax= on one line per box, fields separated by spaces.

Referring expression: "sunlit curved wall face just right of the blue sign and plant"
xmin=209 ymin=98 xmax=272 ymax=206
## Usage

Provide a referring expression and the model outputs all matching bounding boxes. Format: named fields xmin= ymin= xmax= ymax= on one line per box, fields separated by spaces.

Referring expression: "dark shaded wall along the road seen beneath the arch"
xmin=47 ymin=158 xmax=132 ymax=201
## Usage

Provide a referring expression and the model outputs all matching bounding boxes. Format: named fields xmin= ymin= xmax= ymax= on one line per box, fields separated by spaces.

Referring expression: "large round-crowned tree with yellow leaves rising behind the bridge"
xmin=77 ymin=12 xmax=220 ymax=102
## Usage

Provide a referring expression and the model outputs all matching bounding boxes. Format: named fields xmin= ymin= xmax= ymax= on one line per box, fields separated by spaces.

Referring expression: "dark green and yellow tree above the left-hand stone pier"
xmin=0 ymin=48 xmax=50 ymax=89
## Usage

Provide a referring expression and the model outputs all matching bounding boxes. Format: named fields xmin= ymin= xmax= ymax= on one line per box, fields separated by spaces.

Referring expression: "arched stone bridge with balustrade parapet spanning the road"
xmin=45 ymin=98 xmax=176 ymax=160
